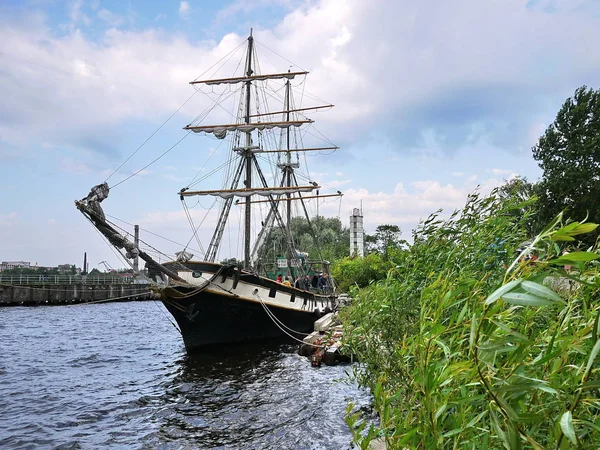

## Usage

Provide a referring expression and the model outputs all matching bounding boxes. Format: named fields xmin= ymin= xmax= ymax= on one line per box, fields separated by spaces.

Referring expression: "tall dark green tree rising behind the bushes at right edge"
xmin=532 ymin=86 xmax=600 ymax=243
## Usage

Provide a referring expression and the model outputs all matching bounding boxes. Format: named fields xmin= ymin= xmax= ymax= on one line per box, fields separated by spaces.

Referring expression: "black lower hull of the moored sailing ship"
xmin=163 ymin=290 xmax=320 ymax=350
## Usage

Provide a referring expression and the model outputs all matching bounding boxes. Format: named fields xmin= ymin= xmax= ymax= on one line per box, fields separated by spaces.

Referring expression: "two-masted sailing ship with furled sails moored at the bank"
xmin=75 ymin=31 xmax=341 ymax=350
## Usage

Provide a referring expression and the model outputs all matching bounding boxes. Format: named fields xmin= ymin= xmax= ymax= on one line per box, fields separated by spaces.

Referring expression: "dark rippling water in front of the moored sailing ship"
xmin=0 ymin=302 xmax=369 ymax=449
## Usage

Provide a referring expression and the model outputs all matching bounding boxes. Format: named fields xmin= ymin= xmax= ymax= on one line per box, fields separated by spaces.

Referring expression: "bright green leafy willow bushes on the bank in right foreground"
xmin=342 ymin=188 xmax=600 ymax=449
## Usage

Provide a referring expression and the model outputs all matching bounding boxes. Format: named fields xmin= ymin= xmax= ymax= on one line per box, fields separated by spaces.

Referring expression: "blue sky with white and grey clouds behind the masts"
xmin=0 ymin=0 xmax=600 ymax=269
